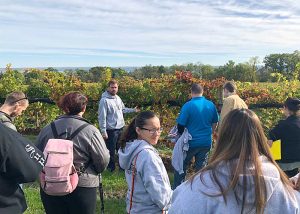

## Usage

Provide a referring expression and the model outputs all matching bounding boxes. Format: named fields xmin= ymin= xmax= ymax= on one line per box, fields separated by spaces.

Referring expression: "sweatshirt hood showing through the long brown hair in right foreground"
xmin=204 ymin=156 xmax=281 ymax=205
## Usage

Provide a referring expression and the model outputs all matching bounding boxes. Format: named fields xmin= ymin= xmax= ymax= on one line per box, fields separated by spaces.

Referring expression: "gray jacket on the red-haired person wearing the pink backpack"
xmin=37 ymin=115 xmax=109 ymax=187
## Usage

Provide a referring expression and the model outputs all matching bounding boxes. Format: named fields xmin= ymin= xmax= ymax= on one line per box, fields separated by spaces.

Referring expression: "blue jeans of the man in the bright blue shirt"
xmin=173 ymin=147 xmax=210 ymax=190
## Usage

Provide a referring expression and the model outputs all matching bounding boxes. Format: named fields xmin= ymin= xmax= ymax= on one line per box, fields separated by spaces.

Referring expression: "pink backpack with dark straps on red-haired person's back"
xmin=40 ymin=122 xmax=89 ymax=196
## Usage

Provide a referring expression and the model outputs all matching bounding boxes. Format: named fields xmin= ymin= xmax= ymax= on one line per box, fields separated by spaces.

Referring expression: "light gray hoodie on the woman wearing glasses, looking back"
xmin=119 ymin=140 xmax=172 ymax=214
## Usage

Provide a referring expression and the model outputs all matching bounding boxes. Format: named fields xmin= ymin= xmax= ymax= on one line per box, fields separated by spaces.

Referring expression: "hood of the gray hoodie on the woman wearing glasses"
xmin=118 ymin=140 xmax=155 ymax=169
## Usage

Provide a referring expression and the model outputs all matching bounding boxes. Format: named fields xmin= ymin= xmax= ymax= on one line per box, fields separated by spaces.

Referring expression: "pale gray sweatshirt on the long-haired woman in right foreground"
xmin=169 ymin=157 xmax=300 ymax=214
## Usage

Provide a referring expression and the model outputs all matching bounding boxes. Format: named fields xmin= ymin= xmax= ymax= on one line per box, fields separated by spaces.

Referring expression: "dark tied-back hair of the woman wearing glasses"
xmin=120 ymin=111 xmax=156 ymax=149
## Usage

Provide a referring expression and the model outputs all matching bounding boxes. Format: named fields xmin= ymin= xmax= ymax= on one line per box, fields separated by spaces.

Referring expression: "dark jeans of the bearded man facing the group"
xmin=105 ymin=129 xmax=122 ymax=171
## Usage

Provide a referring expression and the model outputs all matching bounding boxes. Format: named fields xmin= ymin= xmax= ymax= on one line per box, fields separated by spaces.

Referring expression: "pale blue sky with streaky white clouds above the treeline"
xmin=0 ymin=0 xmax=300 ymax=68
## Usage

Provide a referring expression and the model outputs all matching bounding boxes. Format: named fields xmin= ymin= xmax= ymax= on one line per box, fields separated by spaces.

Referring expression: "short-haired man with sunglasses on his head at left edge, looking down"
xmin=0 ymin=91 xmax=29 ymax=131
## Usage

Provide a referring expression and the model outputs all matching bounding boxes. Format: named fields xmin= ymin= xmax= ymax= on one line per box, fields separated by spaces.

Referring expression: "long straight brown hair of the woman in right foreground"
xmin=190 ymin=109 xmax=292 ymax=214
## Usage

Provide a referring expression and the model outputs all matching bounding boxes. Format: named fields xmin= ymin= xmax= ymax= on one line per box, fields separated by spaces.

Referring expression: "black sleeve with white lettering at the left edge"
xmin=0 ymin=126 xmax=45 ymax=183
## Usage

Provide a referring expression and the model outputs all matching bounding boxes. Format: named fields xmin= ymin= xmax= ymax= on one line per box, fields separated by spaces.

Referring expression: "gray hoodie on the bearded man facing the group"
xmin=98 ymin=91 xmax=135 ymax=135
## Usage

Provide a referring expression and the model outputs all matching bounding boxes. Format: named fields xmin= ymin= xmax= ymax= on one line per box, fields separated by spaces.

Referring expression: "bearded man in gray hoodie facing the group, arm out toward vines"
xmin=98 ymin=80 xmax=139 ymax=172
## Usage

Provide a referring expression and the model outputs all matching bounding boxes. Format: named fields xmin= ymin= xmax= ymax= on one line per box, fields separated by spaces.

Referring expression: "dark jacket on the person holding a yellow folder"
xmin=269 ymin=115 xmax=300 ymax=163
